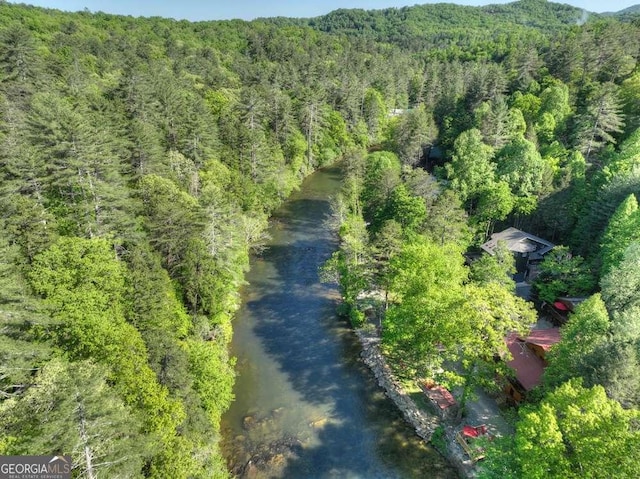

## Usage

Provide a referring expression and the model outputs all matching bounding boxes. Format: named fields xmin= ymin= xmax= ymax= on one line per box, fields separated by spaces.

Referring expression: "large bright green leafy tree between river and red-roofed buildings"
xmin=382 ymin=239 xmax=535 ymax=386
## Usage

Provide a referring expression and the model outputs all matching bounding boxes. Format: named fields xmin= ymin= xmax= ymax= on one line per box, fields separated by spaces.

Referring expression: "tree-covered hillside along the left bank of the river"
xmin=0 ymin=3 xmax=411 ymax=479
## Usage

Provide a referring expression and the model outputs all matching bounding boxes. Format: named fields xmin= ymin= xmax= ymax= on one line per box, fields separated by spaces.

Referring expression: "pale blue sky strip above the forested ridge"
xmin=6 ymin=0 xmax=640 ymax=21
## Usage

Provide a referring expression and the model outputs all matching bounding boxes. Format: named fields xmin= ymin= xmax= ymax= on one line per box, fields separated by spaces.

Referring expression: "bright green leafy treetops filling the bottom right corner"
xmin=481 ymin=380 xmax=640 ymax=478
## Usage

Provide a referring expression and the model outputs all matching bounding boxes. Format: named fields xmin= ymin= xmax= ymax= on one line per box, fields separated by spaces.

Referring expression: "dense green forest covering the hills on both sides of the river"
xmin=0 ymin=0 xmax=640 ymax=478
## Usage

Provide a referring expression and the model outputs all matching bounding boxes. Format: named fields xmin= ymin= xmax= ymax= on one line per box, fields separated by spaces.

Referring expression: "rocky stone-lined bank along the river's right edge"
xmin=355 ymin=328 xmax=484 ymax=479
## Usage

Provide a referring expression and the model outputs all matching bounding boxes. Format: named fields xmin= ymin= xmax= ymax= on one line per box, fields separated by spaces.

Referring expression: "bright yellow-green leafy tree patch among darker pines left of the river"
xmin=29 ymin=238 xmax=184 ymax=437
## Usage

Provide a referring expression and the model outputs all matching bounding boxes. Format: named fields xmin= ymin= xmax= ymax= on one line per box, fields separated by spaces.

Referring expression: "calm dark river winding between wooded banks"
xmin=222 ymin=168 xmax=457 ymax=479
